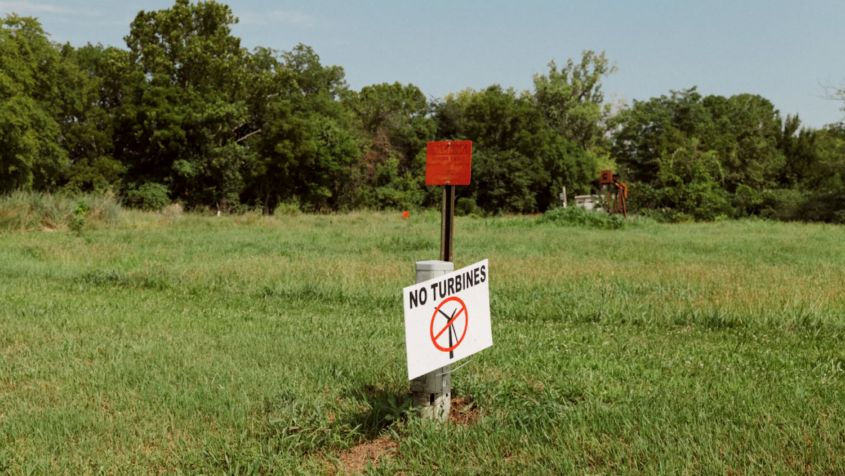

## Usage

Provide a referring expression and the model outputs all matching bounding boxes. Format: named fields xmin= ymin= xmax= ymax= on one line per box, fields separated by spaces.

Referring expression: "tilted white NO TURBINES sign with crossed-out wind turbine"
xmin=402 ymin=260 xmax=493 ymax=379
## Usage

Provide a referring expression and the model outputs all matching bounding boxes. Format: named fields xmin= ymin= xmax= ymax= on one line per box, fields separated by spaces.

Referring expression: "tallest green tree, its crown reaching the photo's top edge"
xmin=119 ymin=0 xmax=251 ymax=208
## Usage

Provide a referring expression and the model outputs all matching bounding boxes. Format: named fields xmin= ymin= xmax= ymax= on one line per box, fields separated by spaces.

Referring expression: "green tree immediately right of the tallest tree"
xmin=245 ymin=45 xmax=360 ymax=210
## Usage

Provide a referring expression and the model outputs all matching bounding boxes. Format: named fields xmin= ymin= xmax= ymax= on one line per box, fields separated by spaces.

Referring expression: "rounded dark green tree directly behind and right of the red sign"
xmin=435 ymin=85 xmax=596 ymax=213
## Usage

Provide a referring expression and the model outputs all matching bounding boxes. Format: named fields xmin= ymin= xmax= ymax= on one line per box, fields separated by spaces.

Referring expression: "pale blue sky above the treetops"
xmin=0 ymin=0 xmax=845 ymax=127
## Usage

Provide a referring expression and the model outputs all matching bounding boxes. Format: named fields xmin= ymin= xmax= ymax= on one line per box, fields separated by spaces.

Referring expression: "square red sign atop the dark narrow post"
xmin=425 ymin=140 xmax=472 ymax=185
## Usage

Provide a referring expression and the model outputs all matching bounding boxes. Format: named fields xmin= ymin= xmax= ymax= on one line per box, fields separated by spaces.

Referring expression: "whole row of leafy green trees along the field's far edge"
xmin=0 ymin=0 xmax=845 ymax=222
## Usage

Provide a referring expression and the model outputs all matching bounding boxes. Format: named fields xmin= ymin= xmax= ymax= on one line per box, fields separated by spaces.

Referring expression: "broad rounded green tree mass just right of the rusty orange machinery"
xmin=613 ymin=88 xmax=796 ymax=220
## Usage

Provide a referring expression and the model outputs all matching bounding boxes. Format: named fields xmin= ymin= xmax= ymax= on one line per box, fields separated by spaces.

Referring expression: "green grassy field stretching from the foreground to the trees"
xmin=0 ymin=213 xmax=845 ymax=475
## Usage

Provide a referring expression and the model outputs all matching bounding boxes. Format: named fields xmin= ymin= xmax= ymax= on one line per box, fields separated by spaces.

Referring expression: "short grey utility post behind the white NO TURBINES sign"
xmin=411 ymin=261 xmax=455 ymax=421
